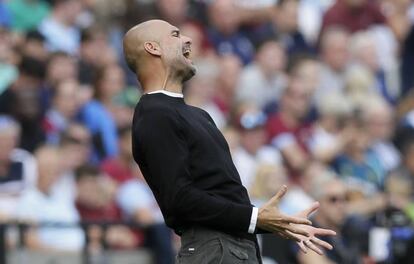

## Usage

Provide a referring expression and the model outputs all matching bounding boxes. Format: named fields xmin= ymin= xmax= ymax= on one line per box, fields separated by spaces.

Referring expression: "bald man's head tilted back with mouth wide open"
xmin=123 ymin=20 xmax=195 ymax=87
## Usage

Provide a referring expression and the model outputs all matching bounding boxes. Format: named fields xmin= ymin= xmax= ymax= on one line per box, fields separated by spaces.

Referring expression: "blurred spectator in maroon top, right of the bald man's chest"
xmin=266 ymin=80 xmax=312 ymax=181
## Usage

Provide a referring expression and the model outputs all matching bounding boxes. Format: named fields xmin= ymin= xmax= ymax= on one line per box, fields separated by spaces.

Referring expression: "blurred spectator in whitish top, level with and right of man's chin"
xmin=236 ymin=40 xmax=287 ymax=108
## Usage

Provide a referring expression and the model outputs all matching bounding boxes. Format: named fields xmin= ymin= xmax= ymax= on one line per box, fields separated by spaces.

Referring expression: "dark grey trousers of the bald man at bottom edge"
xmin=175 ymin=227 xmax=261 ymax=264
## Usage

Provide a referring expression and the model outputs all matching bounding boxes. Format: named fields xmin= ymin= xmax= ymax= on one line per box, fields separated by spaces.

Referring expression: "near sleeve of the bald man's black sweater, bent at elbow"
xmin=134 ymin=110 xmax=252 ymax=232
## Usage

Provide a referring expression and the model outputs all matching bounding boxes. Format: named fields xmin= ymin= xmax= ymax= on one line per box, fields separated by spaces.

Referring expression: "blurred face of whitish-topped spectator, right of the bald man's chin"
xmin=257 ymin=42 xmax=286 ymax=74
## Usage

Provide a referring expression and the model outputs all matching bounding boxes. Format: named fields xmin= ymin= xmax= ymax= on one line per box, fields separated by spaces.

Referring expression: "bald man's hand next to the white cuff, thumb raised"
xmin=257 ymin=185 xmax=312 ymax=241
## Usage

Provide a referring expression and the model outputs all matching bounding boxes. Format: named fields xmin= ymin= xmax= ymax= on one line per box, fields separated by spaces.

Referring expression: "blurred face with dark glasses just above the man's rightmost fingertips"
xmin=318 ymin=180 xmax=347 ymax=227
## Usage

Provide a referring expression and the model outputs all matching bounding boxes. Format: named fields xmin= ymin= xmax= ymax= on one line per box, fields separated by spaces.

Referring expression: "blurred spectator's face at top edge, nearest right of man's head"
xmin=209 ymin=0 xmax=239 ymax=35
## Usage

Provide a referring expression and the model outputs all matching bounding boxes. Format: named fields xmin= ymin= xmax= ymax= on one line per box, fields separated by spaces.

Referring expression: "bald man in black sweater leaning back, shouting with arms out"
xmin=124 ymin=20 xmax=335 ymax=264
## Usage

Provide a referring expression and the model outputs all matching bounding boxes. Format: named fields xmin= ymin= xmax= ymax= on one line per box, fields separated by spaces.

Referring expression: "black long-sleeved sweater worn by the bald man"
xmin=132 ymin=93 xmax=252 ymax=235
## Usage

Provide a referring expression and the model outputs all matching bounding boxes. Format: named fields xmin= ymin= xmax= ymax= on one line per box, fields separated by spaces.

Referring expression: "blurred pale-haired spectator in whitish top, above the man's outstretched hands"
xmin=308 ymin=92 xmax=353 ymax=164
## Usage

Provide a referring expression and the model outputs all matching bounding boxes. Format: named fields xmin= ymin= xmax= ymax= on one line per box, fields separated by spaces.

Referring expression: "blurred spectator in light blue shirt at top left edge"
xmin=39 ymin=0 xmax=82 ymax=55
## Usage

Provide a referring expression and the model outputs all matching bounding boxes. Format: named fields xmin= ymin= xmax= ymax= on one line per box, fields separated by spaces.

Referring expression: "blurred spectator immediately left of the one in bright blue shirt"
xmin=43 ymin=80 xmax=79 ymax=145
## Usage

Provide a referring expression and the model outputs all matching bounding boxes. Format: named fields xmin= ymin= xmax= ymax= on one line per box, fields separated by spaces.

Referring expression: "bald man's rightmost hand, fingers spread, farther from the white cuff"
xmin=288 ymin=202 xmax=336 ymax=255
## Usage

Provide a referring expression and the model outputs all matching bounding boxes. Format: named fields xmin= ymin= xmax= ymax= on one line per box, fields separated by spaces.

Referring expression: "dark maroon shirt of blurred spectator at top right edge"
xmin=321 ymin=0 xmax=386 ymax=33
